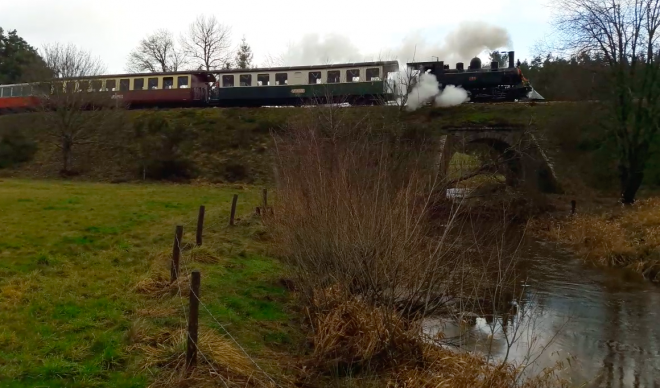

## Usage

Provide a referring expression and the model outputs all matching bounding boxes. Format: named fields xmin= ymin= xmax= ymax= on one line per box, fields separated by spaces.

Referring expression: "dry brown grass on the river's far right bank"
xmin=535 ymin=198 xmax=660 ymax=282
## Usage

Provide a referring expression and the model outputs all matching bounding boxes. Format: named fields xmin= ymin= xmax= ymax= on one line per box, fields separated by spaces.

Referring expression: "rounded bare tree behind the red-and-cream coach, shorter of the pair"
xmin=126 ymin=29 xmax=186 ymax=73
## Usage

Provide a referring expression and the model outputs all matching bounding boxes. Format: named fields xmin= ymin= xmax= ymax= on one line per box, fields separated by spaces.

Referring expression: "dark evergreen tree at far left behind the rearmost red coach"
xmin=0 ymin=27 xmax=48 ymax=84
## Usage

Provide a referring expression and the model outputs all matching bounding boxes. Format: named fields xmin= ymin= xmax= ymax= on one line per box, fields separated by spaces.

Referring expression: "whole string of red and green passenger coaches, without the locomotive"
xmin=0 ymin=61 xmax=399 ymax=113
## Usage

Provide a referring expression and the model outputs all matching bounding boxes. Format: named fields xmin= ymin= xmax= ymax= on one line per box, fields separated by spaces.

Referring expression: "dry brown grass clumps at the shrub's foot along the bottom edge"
xmin=307 ymin=289 xmax=568 ymax=388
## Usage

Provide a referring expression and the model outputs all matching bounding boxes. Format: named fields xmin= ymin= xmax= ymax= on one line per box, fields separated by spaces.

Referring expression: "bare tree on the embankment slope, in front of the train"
xmin=35 ymin=44 xmax=123 ymax=175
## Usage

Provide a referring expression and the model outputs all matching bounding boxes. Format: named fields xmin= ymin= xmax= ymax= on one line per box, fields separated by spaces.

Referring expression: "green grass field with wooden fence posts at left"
xmin=0 ymin=179 xmax=296 ymax=387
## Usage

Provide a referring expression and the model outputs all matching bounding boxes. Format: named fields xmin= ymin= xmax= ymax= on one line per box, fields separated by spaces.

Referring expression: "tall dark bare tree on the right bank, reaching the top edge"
xmin=555 ymin=0 xmax=660 ymax=204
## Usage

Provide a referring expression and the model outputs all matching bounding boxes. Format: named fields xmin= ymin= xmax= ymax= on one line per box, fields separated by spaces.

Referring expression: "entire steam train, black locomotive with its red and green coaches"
xmin=0 ymin=52 xmax=531 ymax=114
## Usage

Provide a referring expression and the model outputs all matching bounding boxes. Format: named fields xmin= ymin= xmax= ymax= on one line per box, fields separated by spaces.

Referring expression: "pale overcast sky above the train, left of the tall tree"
xmin=0 ymin=0 xmax=551 ymax=73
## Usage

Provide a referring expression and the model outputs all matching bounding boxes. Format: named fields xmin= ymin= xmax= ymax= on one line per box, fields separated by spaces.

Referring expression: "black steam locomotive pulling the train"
xmin=407 ymin=51 xmax=533 ymax=102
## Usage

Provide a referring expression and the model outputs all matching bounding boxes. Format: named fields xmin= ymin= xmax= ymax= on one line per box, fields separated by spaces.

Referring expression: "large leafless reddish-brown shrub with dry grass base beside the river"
xmin=265 ymin=106 xmax=568 ymax=387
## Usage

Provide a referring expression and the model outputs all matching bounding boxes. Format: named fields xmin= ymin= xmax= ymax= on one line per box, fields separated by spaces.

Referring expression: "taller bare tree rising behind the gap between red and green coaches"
xmin=181 ymin=15 xmax=232 ymax=71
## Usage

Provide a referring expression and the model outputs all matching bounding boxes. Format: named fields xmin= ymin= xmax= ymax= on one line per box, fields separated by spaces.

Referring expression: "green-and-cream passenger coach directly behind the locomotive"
xmin=209 ymin=61 xmax=399 ymax=106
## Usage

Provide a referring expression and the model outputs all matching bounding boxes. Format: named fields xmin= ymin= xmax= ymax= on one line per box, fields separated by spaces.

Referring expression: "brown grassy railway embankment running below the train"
xmin=0 ymin=103 xmax=640 ymax=192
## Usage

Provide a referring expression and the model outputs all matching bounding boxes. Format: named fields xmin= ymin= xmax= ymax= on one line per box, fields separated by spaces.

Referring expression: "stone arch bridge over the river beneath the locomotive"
xmin=440 ymin=124 xmax=561 ymax=193
